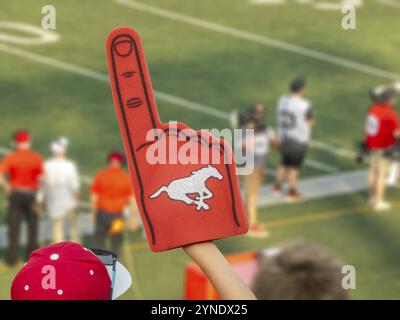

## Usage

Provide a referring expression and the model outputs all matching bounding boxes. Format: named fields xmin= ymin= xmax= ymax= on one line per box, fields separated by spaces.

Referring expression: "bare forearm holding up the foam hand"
xmin=183 ymin=242 xmax=256 ymax=300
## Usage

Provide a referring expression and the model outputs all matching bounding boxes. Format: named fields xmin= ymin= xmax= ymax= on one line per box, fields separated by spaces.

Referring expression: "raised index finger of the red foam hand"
xmin=107 ymin=27 xmax=160 ymax=150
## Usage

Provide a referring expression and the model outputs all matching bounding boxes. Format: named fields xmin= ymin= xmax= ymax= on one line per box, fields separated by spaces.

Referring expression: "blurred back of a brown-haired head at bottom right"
xmin=252 ymin=240 xmax=348 ymax=300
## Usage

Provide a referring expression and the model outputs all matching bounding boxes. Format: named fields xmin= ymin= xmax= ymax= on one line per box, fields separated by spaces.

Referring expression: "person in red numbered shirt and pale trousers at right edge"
xmin=365 ymin=89 xmax=400 ymax=210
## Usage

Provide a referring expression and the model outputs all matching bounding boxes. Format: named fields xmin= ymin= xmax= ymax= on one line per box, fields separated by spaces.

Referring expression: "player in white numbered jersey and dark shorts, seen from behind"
xmin=273 ymin=78 xmax=314 ymax=201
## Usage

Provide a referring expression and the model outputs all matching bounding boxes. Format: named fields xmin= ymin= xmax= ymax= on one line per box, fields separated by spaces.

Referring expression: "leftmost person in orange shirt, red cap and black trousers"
xmin=0 ymin=130 xmax=43 ymax=265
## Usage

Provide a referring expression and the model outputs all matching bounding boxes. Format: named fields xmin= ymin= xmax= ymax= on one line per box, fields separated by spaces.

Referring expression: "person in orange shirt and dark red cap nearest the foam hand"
xmin=91 ymin=151 xmax=135 ymax=255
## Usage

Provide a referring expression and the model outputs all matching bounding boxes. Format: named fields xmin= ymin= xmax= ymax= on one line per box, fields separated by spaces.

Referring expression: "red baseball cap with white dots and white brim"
xmin=11 ymin=242 xmax=132 ymax=300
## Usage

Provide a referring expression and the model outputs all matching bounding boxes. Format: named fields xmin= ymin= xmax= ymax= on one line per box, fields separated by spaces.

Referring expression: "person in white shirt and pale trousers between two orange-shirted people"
xmin=41 ymin=137 xmax=80 ymax=243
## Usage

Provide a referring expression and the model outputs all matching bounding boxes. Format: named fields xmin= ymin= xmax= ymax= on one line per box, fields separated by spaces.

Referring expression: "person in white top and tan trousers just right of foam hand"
xmin=242 ymin=103 xmax=278 ymax=237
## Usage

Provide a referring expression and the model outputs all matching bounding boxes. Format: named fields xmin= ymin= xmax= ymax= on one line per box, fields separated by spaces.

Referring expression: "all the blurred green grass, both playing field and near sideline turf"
xmin=0 ymin=0 xmax=400 ymax=299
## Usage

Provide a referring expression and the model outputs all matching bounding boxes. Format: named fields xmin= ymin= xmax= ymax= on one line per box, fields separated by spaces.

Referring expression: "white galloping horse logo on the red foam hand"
xmin=150 ymin=165 xmax=223 ymax=211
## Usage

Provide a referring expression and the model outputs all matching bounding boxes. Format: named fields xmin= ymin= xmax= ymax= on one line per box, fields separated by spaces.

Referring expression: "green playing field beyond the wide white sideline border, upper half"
xmin=0 ymin=0 xmax=392 ymax=174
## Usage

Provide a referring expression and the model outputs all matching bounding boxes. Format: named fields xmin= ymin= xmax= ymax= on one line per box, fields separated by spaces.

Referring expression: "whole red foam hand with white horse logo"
xmin=107 ymin=27 xmax=248 ymax=251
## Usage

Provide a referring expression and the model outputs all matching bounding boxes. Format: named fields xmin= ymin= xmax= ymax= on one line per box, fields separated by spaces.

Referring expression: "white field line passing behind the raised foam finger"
xmin=0 ymin=44 xmax=350 ymax=168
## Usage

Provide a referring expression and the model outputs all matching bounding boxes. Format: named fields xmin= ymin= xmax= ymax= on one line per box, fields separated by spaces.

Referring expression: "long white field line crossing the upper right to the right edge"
xmin=114 ymin=0 xmax=400 ymax=80
